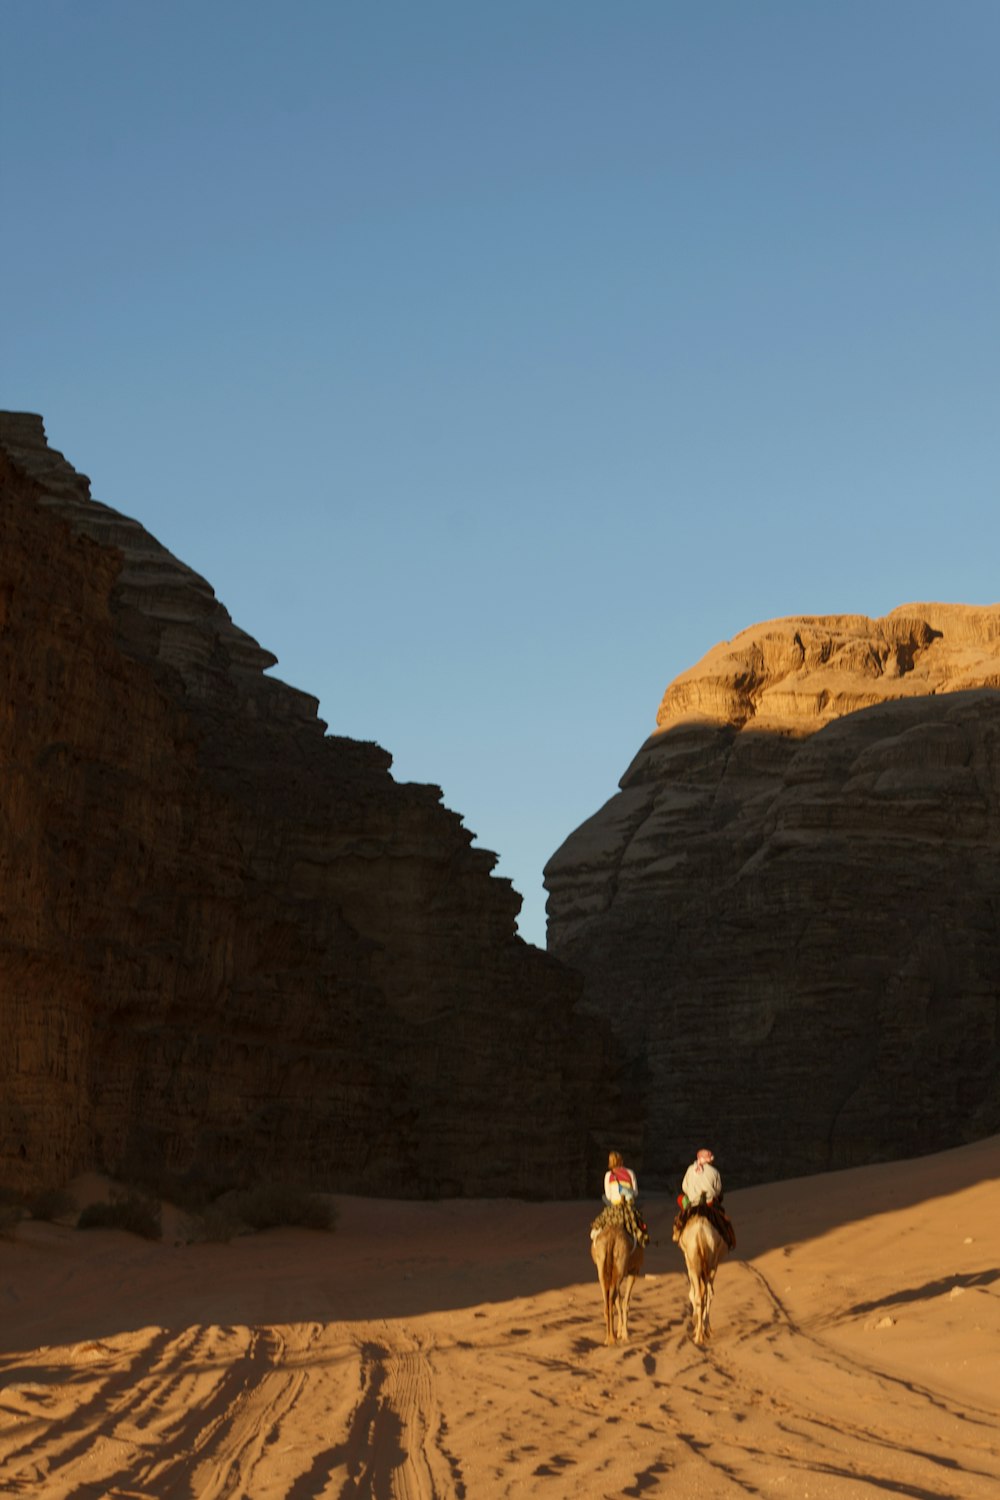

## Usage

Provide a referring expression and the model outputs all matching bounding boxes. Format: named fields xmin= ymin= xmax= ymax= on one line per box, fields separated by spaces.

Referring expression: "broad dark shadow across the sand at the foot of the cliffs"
xmin=0 ymin=1137 xmax=1000 ymax=1356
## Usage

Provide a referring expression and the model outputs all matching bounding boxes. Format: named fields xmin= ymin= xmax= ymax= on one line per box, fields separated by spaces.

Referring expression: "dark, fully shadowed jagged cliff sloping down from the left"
xmin=0 ymin=414 xmax=626 ymax=1196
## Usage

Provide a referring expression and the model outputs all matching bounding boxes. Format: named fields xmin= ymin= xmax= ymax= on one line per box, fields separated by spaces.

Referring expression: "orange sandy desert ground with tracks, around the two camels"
xmin=0 ymin=1139 xmax=1000 ymax=1500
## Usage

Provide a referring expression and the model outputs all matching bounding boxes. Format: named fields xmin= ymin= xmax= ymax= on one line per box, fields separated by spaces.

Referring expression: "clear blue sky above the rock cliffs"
xmin=0 ymin=0 xmax=1000 ymax=944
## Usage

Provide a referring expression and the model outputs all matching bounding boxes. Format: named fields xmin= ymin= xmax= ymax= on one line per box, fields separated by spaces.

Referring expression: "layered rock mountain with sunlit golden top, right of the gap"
xmin=546 ymin=605 xmax=1000 ymax=1185
